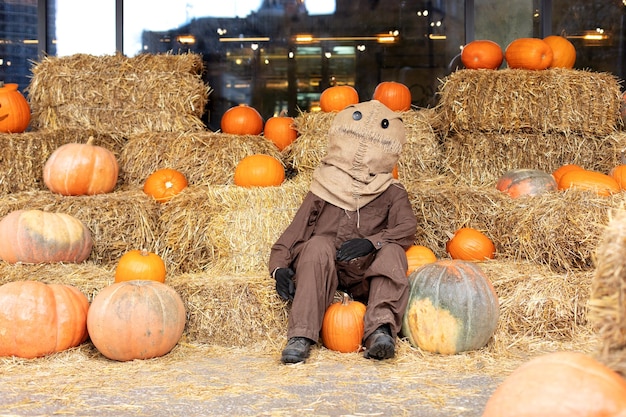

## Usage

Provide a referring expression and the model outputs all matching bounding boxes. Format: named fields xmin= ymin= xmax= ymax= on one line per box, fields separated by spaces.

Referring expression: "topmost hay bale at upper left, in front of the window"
xmin=26 ymin=53 xmax=209 ymax=134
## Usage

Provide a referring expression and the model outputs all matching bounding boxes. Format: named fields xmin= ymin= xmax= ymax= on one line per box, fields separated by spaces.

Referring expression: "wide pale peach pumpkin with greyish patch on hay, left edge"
xmin=0 ymin=210 xmax=93 ymax=264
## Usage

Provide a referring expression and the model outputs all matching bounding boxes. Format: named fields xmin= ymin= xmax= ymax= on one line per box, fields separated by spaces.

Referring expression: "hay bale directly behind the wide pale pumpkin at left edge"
xmin=0 ymin=189 xmax=160 ymax=265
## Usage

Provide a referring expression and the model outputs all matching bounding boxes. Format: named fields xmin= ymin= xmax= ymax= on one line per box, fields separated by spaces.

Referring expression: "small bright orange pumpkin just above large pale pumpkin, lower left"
xmin=115 ymin=249 xmax=166 ymax=282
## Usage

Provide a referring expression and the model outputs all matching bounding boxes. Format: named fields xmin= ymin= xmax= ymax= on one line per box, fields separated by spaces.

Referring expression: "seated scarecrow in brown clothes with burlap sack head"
xmin=269 ymin=100 xmax=417 ymax=364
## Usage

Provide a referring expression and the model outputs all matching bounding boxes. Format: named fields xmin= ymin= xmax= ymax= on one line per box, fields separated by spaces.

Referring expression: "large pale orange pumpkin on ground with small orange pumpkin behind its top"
xmin=87 ymin=280 xmax=186 ymax=361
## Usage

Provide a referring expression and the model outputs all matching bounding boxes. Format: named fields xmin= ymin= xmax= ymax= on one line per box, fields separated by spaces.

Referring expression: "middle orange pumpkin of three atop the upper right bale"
xmin=504 ymin=38 xmax=554 ymax=70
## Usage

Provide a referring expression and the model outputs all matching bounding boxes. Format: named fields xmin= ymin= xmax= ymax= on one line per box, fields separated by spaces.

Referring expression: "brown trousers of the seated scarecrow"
xmin=287 ymin=236 xmax=409 ymax=341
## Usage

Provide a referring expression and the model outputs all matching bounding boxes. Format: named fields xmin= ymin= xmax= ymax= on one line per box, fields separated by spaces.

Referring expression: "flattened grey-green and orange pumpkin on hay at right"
xmin=496 ymin=169 xmax=558 ymax=198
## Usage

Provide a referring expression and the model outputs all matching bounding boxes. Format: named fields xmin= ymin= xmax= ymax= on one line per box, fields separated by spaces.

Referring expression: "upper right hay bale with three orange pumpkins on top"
xmin=437 ymin=68 xmax=621 ymax=136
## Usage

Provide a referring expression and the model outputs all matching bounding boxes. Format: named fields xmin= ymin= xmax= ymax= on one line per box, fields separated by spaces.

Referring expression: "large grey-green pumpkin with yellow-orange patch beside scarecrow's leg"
xmin=402 ymin=259 xmax=499 ymax=354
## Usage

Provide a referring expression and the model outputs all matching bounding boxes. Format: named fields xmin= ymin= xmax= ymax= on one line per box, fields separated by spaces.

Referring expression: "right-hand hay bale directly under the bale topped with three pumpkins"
xmin=442 ymin=131 xmax=626 ymax=185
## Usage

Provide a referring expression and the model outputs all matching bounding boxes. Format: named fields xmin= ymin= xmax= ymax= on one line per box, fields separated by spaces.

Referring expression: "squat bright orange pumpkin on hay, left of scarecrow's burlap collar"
xmin=233 ymin=154 xmax=285 ymax=187
